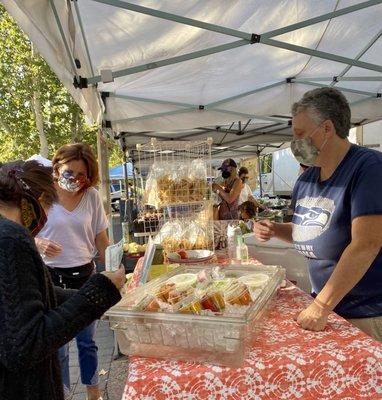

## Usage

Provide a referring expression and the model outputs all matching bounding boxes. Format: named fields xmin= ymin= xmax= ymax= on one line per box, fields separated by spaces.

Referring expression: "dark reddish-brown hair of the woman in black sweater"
xmin=0 ymin=160 xmax=57 ymax=206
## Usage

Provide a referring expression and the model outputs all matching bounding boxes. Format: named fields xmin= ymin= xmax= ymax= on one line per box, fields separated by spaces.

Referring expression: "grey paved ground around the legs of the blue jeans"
xmin=69 ymin=321 xmax=128 ymax=400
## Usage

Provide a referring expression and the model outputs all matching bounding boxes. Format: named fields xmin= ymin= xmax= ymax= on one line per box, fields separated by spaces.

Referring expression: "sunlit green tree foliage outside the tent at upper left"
xmin=0 ymin=5 xmax=97 ymax=162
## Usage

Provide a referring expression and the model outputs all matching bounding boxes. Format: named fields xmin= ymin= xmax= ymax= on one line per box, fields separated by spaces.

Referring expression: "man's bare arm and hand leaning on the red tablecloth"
xmin=297 ymin=215 xmax=382 ymax=330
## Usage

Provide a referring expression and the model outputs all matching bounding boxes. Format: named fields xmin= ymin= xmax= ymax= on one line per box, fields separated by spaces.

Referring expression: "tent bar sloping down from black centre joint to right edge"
xmin=260 ymin=36 xmax=382 ymax=72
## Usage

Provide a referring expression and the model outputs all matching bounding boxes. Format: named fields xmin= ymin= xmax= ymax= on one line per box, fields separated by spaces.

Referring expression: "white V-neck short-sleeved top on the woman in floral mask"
xmin=37 ymin=188 xmax=108 ymax=268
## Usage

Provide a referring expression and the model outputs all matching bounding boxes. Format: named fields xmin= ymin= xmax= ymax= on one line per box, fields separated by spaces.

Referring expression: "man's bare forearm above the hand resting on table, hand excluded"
xmin=317 ymin=243 xmax=380 ymax=310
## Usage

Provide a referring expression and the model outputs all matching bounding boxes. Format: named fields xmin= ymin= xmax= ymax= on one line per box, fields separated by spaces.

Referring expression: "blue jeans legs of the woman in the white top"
xmin=58 ymin=322 xmax=98 ymax=390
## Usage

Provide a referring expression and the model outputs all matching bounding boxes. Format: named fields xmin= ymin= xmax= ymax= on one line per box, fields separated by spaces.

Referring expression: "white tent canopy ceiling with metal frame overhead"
xmin=0 ymin=0 xmax=382 ymax=154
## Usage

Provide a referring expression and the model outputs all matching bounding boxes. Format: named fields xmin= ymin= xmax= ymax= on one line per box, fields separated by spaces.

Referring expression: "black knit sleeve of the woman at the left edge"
xmin=0 ymin=237 xmax=121 ymax=370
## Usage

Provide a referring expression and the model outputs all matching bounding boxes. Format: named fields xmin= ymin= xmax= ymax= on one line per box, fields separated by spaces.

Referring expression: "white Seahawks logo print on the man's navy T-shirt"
xmin=293 ymin=197 xmax=335 ymax=258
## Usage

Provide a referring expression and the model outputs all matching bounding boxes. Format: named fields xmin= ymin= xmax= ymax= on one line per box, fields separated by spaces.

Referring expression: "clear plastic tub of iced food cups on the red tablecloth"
xmin=106 ymin=264 xmax=285 ymax=367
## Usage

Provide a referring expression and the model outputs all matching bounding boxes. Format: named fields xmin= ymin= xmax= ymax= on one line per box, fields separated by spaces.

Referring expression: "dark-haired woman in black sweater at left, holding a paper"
xmin=0 ymin=161 xmax=125 ymax=400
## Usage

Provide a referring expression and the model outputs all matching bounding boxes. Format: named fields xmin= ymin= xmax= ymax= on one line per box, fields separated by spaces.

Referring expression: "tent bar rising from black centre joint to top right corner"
xmin=261 ymin=0 xmax=382 ymax=38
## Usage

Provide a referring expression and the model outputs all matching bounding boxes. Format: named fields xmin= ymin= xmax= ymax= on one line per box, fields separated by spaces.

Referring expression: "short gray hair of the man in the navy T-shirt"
xmin=292 ymin=87 xmax=351 ymax=138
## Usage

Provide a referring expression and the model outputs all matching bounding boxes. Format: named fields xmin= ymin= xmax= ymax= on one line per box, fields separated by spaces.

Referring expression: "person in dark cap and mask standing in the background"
xmin=212 ymin=158 xmax=243 ymax=220
